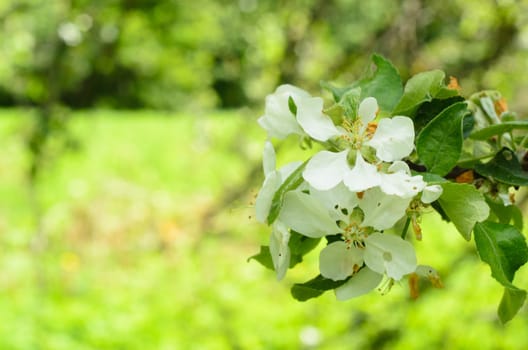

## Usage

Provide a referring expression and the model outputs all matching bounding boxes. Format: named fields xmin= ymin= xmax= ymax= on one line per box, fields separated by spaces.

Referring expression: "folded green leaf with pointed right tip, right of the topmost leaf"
xmin=393 ymin=70 xmax=458 ymax=117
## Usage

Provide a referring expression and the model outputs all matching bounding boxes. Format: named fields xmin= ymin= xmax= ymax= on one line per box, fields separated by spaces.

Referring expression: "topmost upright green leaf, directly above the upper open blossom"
xmin=357 ymin=54 xmax=403 ymax=112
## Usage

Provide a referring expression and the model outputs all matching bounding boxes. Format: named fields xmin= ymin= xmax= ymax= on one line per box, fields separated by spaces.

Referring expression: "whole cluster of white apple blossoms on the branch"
xmin=255 ymin=85 xmax=442 ymax=300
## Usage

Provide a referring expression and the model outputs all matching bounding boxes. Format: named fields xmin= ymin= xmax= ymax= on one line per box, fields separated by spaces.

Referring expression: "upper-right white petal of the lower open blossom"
xmin=359 ymin=187 xmax=412 ymax=230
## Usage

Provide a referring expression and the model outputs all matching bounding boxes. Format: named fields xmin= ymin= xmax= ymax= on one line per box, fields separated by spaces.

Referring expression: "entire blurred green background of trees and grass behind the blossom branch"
xmin=0 ymin=0 xmax=528 ymax=349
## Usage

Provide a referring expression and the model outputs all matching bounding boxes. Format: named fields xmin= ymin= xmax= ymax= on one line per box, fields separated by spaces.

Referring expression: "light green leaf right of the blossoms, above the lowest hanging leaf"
xmin=438 ymin=182 xmax=489 ymax=241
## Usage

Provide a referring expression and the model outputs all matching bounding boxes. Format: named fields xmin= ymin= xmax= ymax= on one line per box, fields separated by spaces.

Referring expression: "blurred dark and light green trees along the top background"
xmin=0 ymin=0 xmax=528 ymax=109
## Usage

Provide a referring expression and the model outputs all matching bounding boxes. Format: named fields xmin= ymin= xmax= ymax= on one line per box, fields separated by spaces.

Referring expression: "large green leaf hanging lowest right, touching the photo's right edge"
xmin=474 ymin=221 xmax=528 ymax=288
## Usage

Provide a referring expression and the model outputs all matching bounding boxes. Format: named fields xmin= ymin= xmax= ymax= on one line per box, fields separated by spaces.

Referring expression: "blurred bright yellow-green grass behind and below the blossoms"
xmin=0 ymin=110 xmax=528 ymax=349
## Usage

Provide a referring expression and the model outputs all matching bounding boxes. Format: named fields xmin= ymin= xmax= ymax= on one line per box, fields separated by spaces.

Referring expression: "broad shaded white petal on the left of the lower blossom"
xmin=278 ymin=191 xmax=339 ymax=238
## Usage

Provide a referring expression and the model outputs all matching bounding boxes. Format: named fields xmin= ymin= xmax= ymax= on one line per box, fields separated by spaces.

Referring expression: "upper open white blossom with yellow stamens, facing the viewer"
xmin=303 ymin=97 xmax=416 ymax=196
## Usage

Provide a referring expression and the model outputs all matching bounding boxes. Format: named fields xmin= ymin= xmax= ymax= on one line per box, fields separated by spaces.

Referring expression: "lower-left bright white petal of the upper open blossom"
xmin=303 ymin=150 xmax=350 ymax=191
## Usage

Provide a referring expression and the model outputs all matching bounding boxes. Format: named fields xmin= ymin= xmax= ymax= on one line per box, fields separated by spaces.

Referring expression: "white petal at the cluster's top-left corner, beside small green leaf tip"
xmin=258 ymin=85 xmax=310 ymax=139
